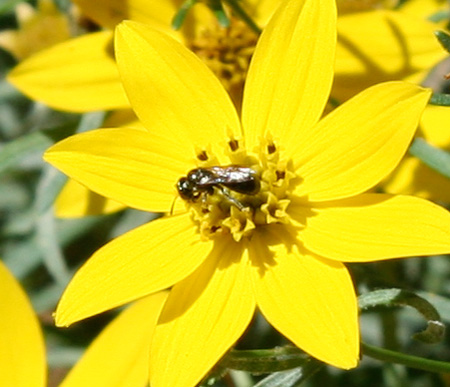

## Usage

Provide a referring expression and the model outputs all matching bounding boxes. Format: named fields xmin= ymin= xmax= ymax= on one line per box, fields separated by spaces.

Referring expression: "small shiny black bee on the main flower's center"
xmin=177 ymin=165 xmax=261 ymax=211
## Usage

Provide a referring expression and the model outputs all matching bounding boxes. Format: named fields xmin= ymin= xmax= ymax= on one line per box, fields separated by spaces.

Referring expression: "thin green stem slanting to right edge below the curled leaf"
xmin=361 ymin=343 xmax=450 ymax=373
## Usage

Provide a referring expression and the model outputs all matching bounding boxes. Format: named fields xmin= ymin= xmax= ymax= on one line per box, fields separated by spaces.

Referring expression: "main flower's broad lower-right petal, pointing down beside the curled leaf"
xmin=250 ymin=230 xmax=359 ymax=369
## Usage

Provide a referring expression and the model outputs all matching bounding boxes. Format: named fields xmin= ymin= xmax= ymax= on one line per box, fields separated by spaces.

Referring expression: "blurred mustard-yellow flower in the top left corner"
xmin=0 ymin=0 xmax=70 ymax=59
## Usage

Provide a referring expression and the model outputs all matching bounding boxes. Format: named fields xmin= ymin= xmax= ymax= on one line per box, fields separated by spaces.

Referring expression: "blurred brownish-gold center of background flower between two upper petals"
xmin=188 ymin=17 xmax=258 ymax=109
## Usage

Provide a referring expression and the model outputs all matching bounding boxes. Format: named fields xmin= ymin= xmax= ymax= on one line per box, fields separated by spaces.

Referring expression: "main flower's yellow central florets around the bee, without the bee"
xmin=179 ymin=137 xmax=298 ymax=241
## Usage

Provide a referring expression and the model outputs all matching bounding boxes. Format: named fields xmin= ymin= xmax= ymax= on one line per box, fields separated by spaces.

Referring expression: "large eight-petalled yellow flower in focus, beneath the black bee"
xmin=45 ymin=0 xmax=450 ymax=387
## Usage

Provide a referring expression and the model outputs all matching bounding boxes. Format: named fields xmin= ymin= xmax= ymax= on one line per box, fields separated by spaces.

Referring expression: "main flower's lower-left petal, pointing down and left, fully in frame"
xmin=56 ymin=214 xmax=212 ymax=326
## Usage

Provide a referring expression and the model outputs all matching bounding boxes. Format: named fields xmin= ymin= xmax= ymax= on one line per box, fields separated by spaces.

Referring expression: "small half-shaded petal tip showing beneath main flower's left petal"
xmin=55 ymin=179 xmax=126 ymax=218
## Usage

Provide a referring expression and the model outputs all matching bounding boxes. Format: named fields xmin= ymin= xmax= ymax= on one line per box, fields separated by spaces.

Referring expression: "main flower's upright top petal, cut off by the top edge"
xmin=242 ymin=0 xmax=336 ymax=149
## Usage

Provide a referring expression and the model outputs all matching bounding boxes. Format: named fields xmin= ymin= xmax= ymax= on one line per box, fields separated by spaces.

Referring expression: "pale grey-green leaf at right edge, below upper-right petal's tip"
xmin=409 ymin=138 xmax=450 ymax=182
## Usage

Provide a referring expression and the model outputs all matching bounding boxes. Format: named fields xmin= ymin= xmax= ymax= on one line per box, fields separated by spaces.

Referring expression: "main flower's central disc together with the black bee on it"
xmin=177 ymin=138 xmax=298 ymax=241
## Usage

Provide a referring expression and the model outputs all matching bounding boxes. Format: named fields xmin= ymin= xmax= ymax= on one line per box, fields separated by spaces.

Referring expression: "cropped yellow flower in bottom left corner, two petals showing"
xmin=0 ymin=261 xmax=167 ymax=387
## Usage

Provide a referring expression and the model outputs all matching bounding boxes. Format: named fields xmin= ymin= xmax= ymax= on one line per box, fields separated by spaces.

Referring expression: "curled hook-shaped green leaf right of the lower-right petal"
xmin=358 ymin=289 xmax=445 ymax=343
